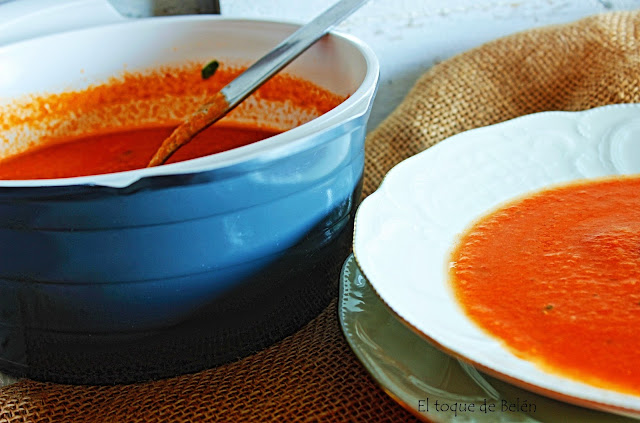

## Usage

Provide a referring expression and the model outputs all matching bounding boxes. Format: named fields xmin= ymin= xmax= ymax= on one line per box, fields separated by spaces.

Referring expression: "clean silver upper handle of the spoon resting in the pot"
xmin=221 ymin=0 xmax=368 ymax=110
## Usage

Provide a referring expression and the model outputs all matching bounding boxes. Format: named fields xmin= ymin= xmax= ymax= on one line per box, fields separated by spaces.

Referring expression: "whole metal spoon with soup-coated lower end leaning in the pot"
xmin=147 ymin=0 xmax=368 ymax=167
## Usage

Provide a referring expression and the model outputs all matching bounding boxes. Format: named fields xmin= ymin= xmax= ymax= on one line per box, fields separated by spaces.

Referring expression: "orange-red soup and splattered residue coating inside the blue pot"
xmin=0 ymin=63 xmax=346 ymax=180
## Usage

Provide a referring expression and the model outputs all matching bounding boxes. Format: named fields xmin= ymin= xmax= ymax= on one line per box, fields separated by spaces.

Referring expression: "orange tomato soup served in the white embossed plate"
xmin=450 ymin=177 xmax=640 ymax=395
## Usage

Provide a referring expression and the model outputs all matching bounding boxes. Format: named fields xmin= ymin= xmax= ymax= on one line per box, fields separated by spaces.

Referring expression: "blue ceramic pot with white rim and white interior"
xmin=0 ymin=0 xmax=378 ymax=384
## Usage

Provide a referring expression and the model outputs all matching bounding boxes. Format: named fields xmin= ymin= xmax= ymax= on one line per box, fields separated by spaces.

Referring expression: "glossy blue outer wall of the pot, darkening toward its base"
xmin=0 ymin=113 xmax=368 ymax=384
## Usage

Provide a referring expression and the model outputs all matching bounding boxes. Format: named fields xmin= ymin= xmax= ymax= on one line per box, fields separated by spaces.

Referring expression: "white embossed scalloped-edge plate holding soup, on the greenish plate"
xmin=354 ymin=104 xmax=640 ymax=416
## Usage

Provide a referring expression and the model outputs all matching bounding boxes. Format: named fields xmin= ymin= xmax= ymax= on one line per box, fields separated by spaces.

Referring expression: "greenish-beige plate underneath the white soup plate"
xmin=339 ymin=256 xmax=634 ymax=423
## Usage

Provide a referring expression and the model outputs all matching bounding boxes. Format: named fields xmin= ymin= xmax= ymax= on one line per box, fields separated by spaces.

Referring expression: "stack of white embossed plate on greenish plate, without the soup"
xmin=340 ymin=104 xmax=640 ymax=422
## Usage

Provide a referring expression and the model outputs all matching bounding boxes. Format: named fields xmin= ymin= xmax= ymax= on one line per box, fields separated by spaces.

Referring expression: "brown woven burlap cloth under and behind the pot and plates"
xmin=0 ymin=12 xmax=640 ymax=422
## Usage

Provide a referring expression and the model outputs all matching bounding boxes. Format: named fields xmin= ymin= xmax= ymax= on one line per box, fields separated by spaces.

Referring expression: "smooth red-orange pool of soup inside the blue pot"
xmin=0 ymin=125 xmax=278 ymax=180
